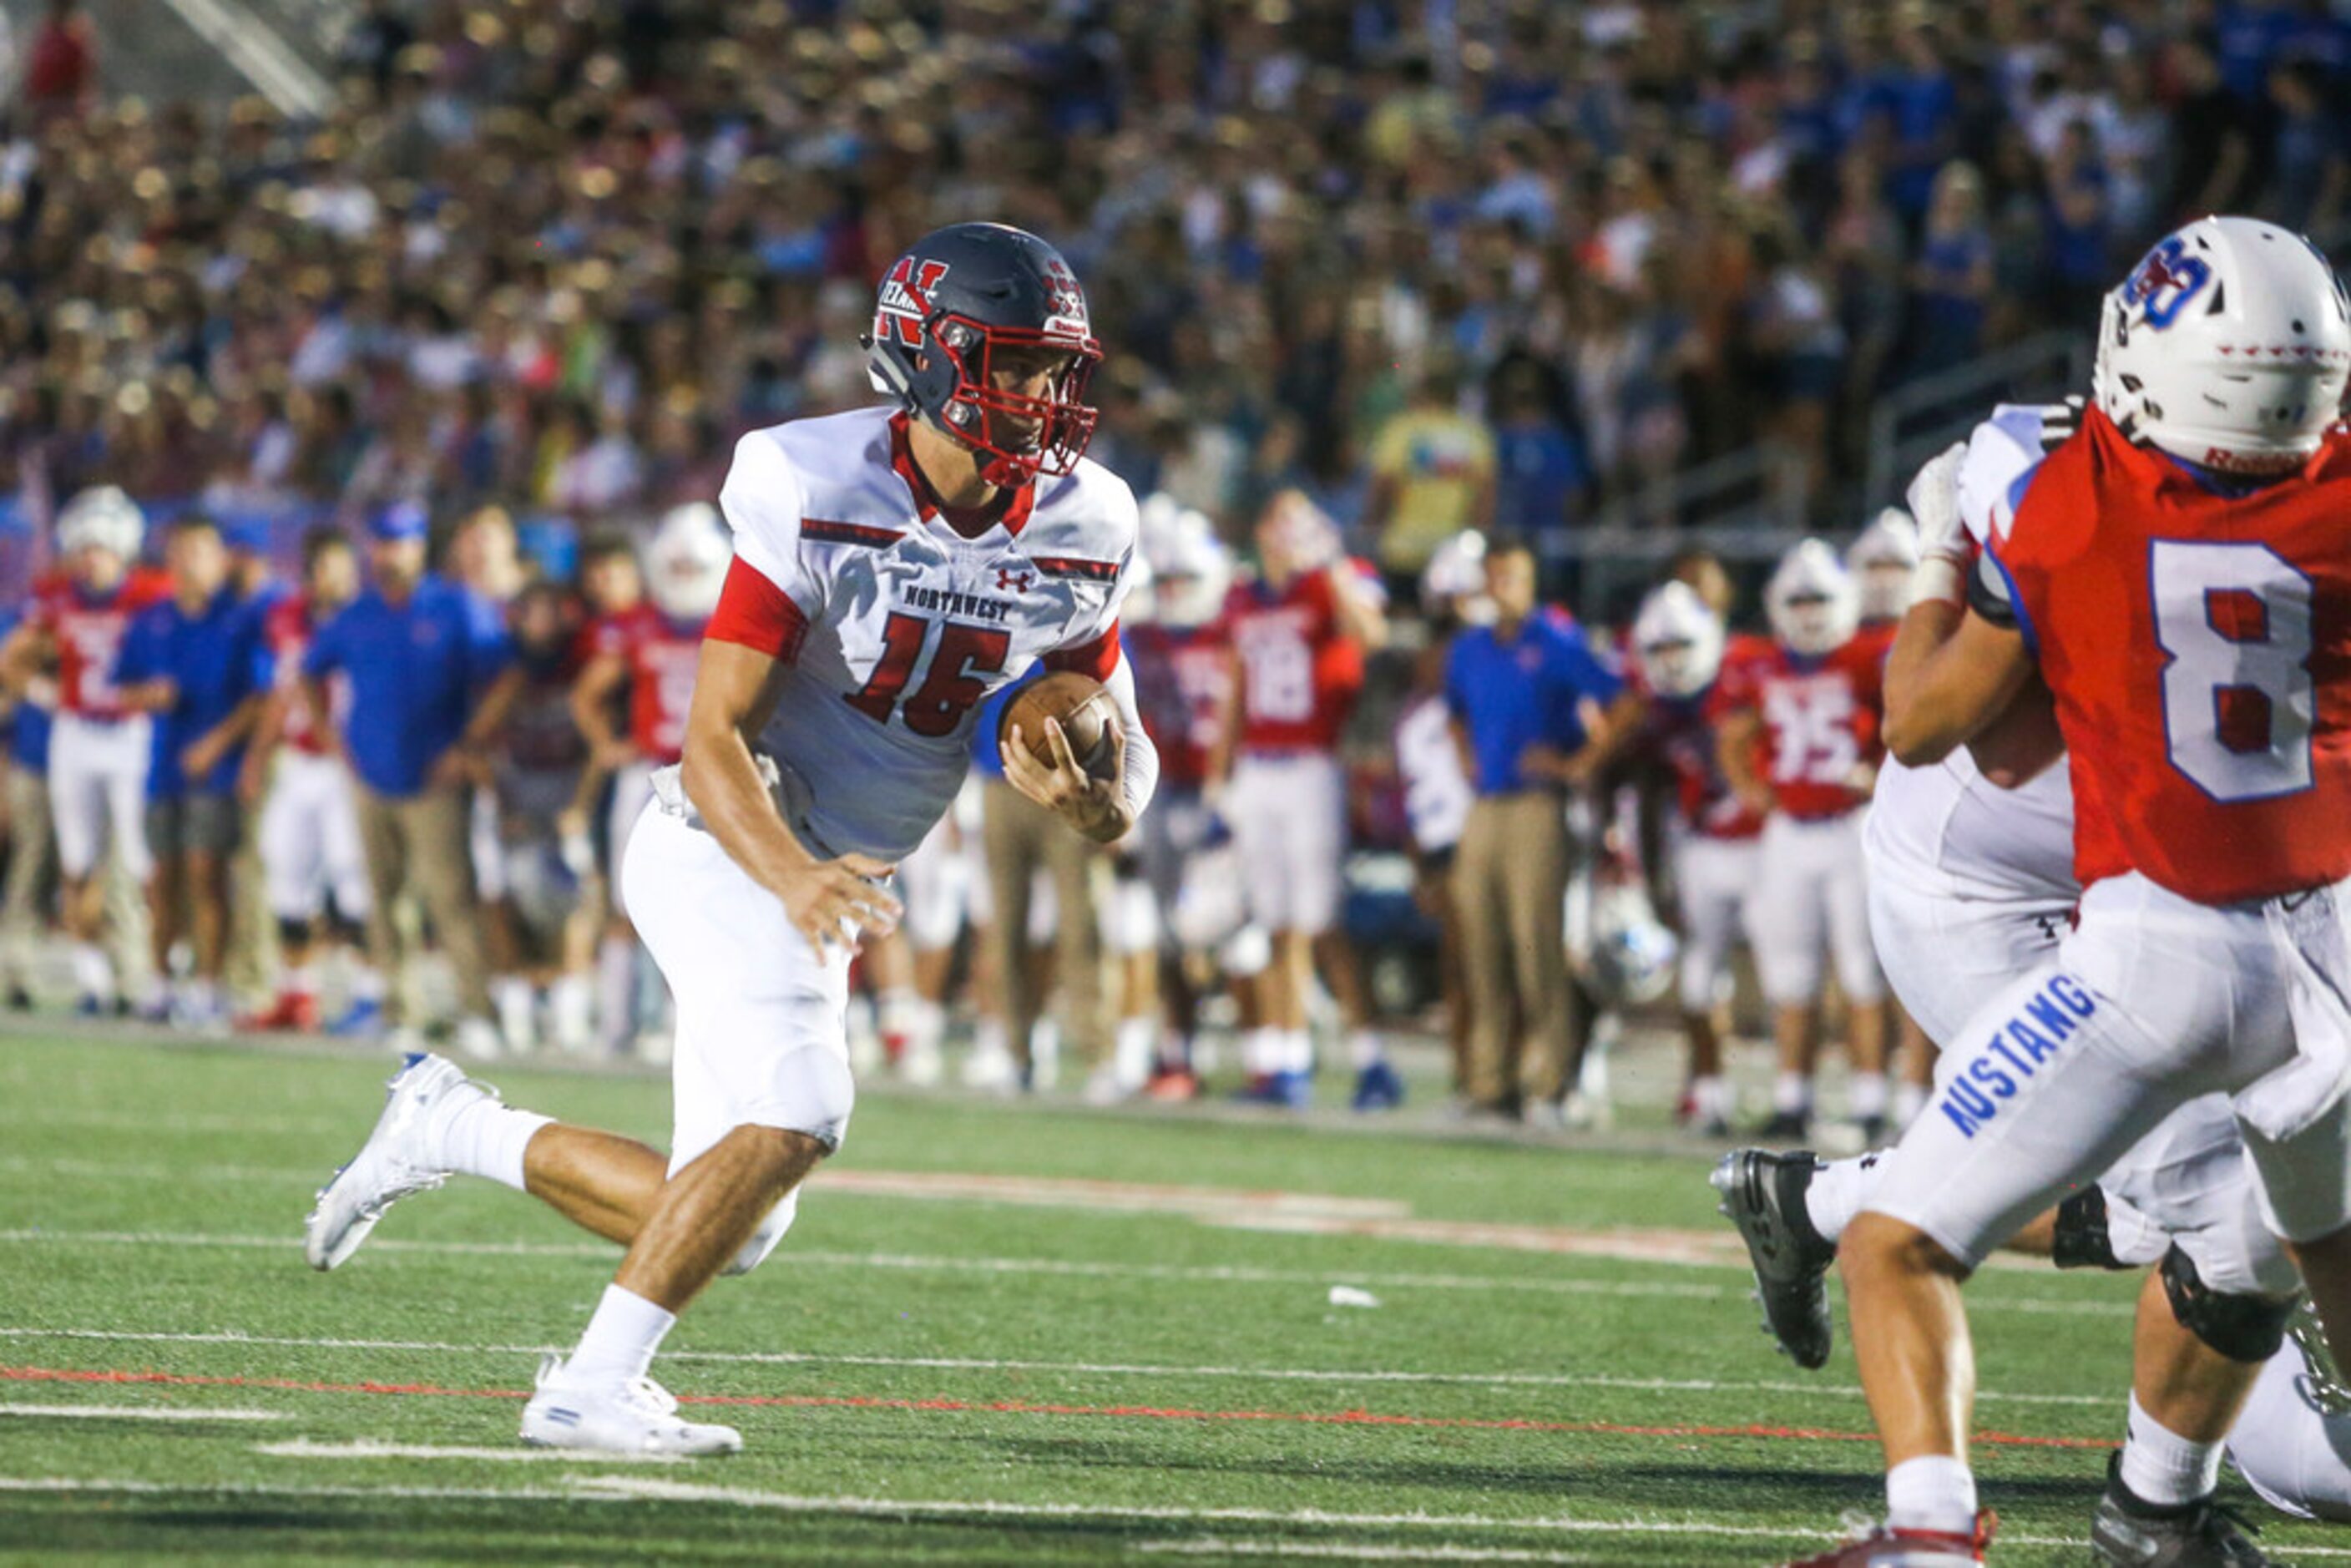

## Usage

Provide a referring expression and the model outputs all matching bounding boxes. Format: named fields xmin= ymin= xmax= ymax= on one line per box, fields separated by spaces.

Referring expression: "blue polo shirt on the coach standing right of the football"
xmin=1446 ymin=609 xmax=1625 ymax=795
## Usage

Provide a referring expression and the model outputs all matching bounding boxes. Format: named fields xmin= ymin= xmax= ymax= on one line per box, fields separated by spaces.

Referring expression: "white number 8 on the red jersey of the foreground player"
xmin=2149 ymin=539 xmax=2318 ymax=802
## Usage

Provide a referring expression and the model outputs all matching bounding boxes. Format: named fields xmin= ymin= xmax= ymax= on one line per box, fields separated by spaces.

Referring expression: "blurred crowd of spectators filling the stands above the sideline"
xmin=0 ymin=0 xmax=2351 ymax=594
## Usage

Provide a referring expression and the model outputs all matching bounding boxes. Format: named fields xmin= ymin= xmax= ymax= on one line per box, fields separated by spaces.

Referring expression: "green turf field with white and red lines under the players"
xmin=0 ymin=1034 xmax=2323 ymax=1563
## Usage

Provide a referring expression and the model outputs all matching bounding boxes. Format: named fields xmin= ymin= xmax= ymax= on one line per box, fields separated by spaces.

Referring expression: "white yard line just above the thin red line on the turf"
xmin=0 ymin=1326 xmax=2121 ymax=1409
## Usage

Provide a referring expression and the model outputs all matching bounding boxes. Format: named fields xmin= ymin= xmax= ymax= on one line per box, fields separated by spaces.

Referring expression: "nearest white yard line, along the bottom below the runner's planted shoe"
xmin=0 ymin=1455 xmax=2351 ymax=1559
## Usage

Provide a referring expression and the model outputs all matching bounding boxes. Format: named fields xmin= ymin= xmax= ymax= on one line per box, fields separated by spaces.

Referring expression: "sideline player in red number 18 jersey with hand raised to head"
xmin=1211 ymin=491 xmax=1394 ymax=1107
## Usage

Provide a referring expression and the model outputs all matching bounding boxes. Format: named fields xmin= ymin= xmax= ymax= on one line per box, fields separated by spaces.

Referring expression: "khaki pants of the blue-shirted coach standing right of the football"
xmin=1453 ymin=790 xmax=1575 ymax=1105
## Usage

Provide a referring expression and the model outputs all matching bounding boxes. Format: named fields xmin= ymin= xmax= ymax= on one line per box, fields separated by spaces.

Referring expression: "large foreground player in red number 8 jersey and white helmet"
xmin=1820 ymin=219 xmax=2351 ymax=1565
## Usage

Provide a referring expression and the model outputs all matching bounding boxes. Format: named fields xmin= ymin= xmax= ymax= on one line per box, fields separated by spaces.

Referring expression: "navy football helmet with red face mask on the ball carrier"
xmin=862 ymin=223 xmax=1103 ymax=487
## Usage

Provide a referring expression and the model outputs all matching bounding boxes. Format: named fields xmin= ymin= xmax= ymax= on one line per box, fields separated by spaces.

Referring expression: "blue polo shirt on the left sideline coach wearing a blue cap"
xmin=303 ymin=576 xmax=508 ymax=795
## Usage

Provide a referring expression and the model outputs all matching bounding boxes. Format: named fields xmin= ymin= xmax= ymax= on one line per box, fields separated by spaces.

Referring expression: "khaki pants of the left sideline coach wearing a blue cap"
xmin=352 ymin=783 xmax=489 ymax=1023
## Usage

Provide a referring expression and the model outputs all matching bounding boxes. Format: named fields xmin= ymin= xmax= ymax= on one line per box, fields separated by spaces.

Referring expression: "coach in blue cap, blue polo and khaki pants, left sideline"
xmin=303 ymin=503 xmax=513 ymax=1055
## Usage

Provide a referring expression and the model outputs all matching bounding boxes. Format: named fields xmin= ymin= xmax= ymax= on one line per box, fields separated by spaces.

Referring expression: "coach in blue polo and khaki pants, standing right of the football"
xmin=1446 ymin=541 xmax=1639 ymax=1119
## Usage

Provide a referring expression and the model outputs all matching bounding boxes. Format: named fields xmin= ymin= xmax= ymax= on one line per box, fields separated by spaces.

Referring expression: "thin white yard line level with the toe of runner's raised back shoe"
xmin=0 ymin=1230 xmax=2132 ymax=1319
